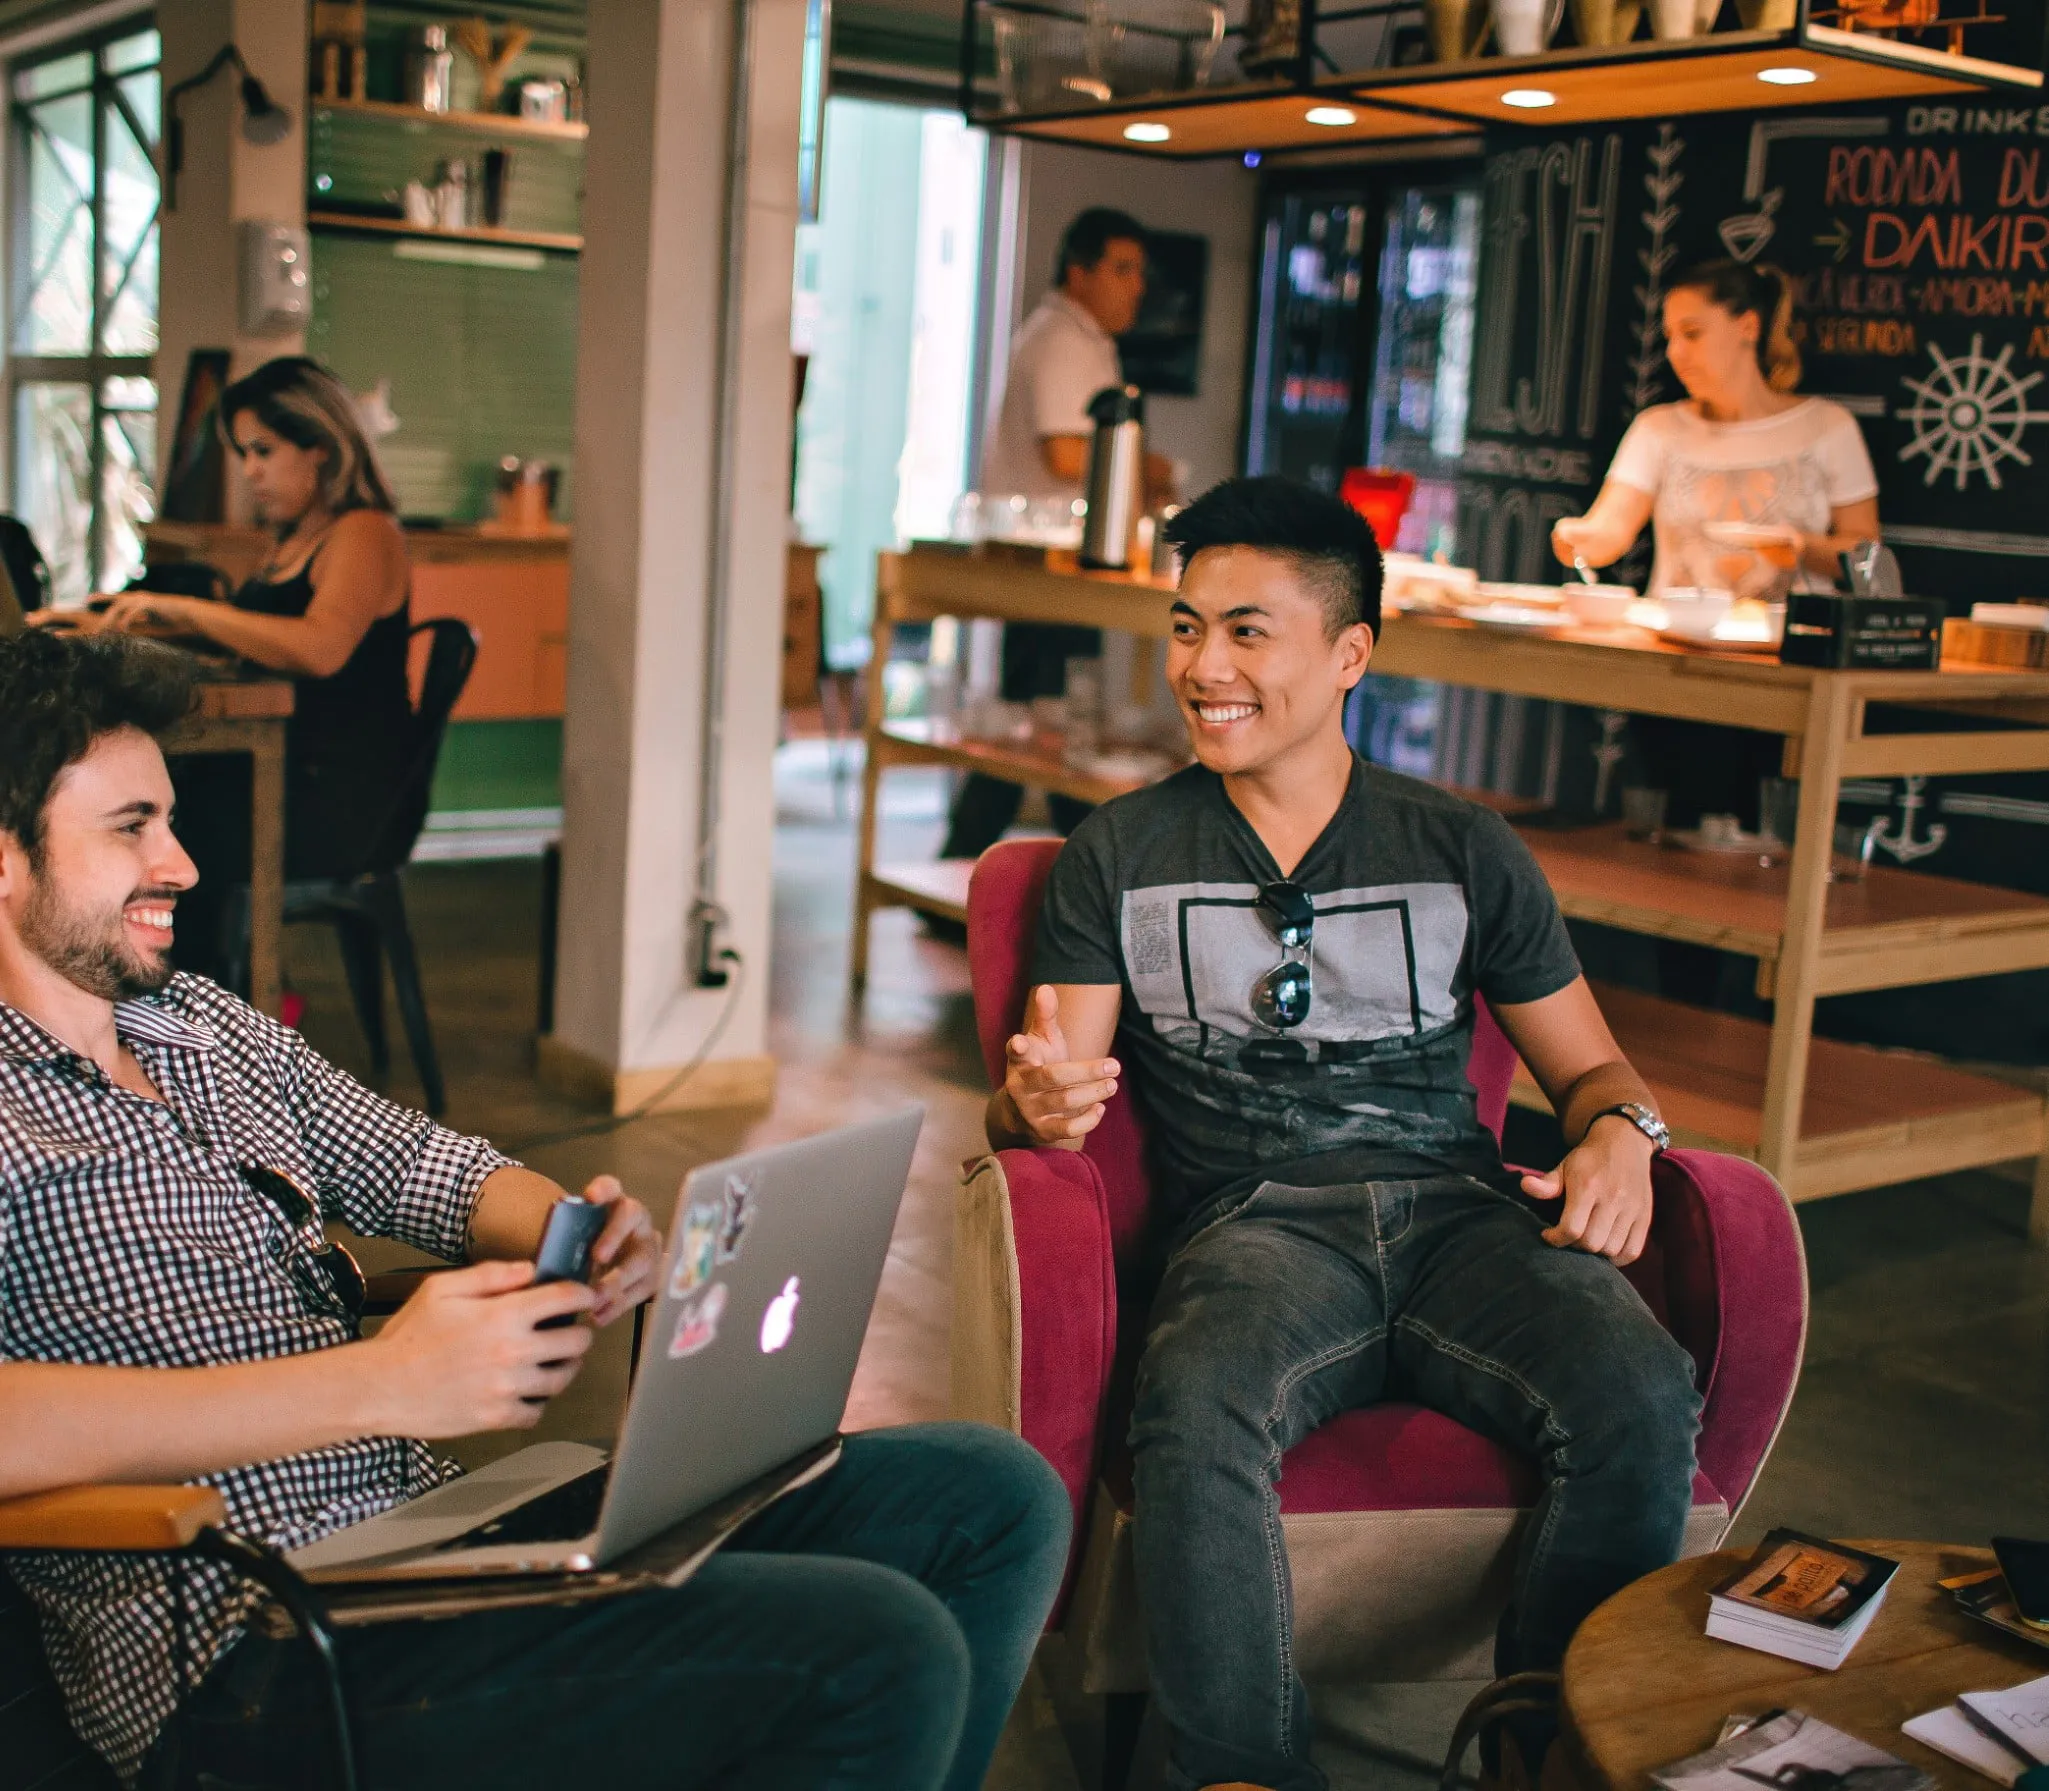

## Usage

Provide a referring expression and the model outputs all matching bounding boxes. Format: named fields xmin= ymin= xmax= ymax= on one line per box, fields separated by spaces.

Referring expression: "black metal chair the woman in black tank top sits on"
xmin=238 ymin=617 xmax=477 ymax=1119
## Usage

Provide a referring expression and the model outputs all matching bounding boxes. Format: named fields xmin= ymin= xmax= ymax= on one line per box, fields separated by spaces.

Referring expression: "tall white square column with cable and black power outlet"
xmin=541 ymin=0 xmax=803 ymax=1111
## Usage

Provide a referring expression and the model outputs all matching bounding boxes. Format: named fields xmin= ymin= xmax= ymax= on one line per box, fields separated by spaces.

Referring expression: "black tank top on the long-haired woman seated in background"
xmin=234 ymin=520 xmax=412 ymax=877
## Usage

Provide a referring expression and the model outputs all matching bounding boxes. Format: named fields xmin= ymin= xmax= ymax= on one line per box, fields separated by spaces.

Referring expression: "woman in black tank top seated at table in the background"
xmin=85 ymin=355 xmax=412 ymax=975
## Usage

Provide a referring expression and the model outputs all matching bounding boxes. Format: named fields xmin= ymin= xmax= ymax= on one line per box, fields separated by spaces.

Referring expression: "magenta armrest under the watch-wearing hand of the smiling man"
xmin=1654 ymin=1150 xmax=1807 ymax=1514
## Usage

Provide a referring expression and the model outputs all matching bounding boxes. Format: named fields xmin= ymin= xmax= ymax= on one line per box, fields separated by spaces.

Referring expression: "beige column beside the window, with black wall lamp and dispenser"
xmin=156 ymin=0 xmax=307 ymax=485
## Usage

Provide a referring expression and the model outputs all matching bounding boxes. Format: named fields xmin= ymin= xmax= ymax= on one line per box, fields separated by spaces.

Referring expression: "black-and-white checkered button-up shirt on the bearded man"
xmin=0 ymin=975 xmax=508 ymax=1779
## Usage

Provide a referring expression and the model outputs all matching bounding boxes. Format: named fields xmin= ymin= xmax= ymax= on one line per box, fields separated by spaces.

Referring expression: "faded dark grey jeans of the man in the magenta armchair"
xmin=1131 ymin=1176 xmax=1701 ymax=1791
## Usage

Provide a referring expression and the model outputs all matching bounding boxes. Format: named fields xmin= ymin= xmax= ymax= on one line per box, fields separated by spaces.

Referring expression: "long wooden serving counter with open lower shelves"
xmin=854 ymin=549 xmax=2049 ymax=1242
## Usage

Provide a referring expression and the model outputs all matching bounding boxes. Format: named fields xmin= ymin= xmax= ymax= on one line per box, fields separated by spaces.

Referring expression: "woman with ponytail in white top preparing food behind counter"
xmin=1551 ymin=260 xmax=1879 ymax=602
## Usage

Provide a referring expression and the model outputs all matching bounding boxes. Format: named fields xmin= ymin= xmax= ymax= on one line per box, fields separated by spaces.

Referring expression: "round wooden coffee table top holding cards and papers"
xmin=1563 ymin=1543 xmax=2049 ymax=1791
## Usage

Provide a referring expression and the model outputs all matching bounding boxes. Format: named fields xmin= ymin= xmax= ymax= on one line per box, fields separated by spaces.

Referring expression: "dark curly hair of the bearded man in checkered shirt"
xmin=0 ymin=629 xmax=195 ymax=863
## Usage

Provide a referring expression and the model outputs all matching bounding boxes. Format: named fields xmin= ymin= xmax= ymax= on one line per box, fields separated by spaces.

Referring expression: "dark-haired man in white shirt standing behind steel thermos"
xmin=940 ymin=205 xmax=1172 ymax=859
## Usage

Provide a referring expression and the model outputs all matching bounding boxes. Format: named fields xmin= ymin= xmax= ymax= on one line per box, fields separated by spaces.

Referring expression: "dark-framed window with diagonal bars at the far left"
xmin=0 ymin=10 xmax=164 ymax=588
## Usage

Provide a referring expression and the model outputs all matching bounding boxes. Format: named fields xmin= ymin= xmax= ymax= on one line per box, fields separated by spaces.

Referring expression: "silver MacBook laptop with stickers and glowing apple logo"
xmin=287 ymin=1107 xmax=924 ymax=1584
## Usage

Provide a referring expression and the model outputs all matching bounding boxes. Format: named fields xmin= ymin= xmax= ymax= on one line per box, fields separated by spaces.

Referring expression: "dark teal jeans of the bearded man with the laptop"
xmin=143 ymin=1424 xmax=1068 ymax=1791
